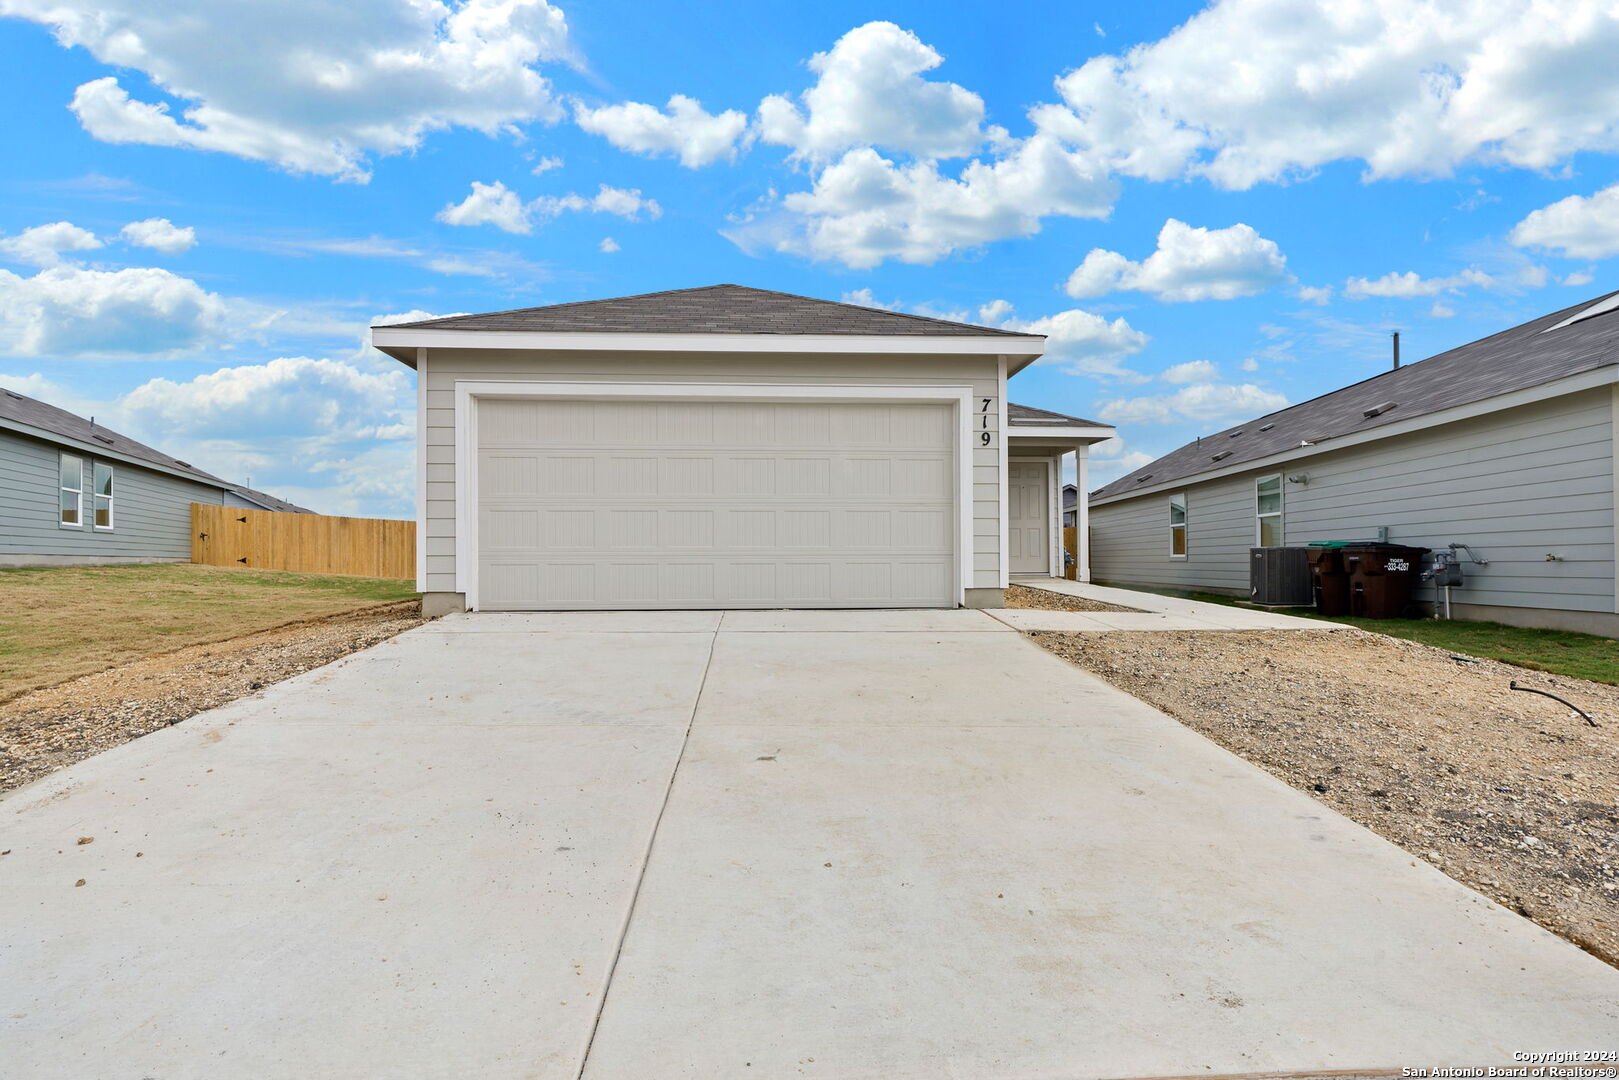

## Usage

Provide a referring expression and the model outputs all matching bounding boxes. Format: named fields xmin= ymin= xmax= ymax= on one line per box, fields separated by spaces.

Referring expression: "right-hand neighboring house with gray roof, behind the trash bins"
xmin=1091 ymin=293 xmax=1619 ymax=635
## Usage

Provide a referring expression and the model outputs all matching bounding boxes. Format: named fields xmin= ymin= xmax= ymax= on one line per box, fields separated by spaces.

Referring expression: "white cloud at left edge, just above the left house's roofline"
xmin=0 ymin=267 xmax=230 ymax=358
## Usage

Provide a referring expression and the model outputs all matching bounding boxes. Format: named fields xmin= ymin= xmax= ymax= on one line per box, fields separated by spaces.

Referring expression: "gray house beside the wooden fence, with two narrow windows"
xmin=0 ymin=389 xmax=309 ymax=567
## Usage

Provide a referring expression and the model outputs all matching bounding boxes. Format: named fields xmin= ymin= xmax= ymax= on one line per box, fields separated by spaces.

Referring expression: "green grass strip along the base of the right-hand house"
xmin=1098 ymin=583 xmax=1619 ymax=685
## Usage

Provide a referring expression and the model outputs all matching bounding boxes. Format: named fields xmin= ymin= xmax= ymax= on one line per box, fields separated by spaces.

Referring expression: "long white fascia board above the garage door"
xmin=371 ymin=327 xmax=1046 ymax=359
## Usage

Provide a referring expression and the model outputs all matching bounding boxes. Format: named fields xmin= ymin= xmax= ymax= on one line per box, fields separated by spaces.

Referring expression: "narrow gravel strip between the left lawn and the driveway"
xmin=0 ymin=601 xmax=426 ymax=792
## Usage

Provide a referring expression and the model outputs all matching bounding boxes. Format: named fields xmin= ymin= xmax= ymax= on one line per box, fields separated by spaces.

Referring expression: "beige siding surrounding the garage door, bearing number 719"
xmin=421 ymin=348 xmax=1002 ymax=593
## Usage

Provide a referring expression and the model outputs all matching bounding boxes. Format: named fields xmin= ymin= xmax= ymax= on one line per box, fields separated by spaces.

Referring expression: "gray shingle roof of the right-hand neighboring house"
xmin=1091 ymin=293 xmax=1619 ymax=499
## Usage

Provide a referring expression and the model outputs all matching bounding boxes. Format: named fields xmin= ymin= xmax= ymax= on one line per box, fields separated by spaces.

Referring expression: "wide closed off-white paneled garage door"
xmin=478 ymin=398 xmax=957 ymax=610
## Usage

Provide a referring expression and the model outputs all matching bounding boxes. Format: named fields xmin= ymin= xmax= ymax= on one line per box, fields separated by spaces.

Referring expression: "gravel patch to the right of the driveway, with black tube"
xmin=1030 ymin=630 xmax=1619 ymax=967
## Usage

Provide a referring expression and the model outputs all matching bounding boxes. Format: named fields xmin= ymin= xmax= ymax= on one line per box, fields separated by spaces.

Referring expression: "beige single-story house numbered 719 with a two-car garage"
xmin=372 ymin=285 xmax=1114 ymax=612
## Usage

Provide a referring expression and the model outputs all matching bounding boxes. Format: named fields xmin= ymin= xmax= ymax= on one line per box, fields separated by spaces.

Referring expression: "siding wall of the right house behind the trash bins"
xmin=1091 ymin=387 xmax=1616 ymax=612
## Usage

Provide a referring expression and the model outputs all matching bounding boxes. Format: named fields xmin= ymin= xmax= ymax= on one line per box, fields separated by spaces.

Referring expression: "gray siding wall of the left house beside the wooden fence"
xmin=0 ymin=431 xmax=222 ymax=560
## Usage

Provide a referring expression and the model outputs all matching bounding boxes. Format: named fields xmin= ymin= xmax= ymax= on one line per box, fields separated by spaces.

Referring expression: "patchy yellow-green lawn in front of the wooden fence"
xmin=0 ymin=563 xmax=416 ymax=701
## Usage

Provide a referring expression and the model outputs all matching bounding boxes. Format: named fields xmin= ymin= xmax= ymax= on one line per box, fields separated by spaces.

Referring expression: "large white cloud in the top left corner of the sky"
xmin=11 ymin=0 xmax=573 ymax=181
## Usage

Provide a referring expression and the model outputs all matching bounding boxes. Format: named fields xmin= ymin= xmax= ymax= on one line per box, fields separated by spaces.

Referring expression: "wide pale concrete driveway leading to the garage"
xmin=0 ymin=610 xmax=1619 ymax=1080
